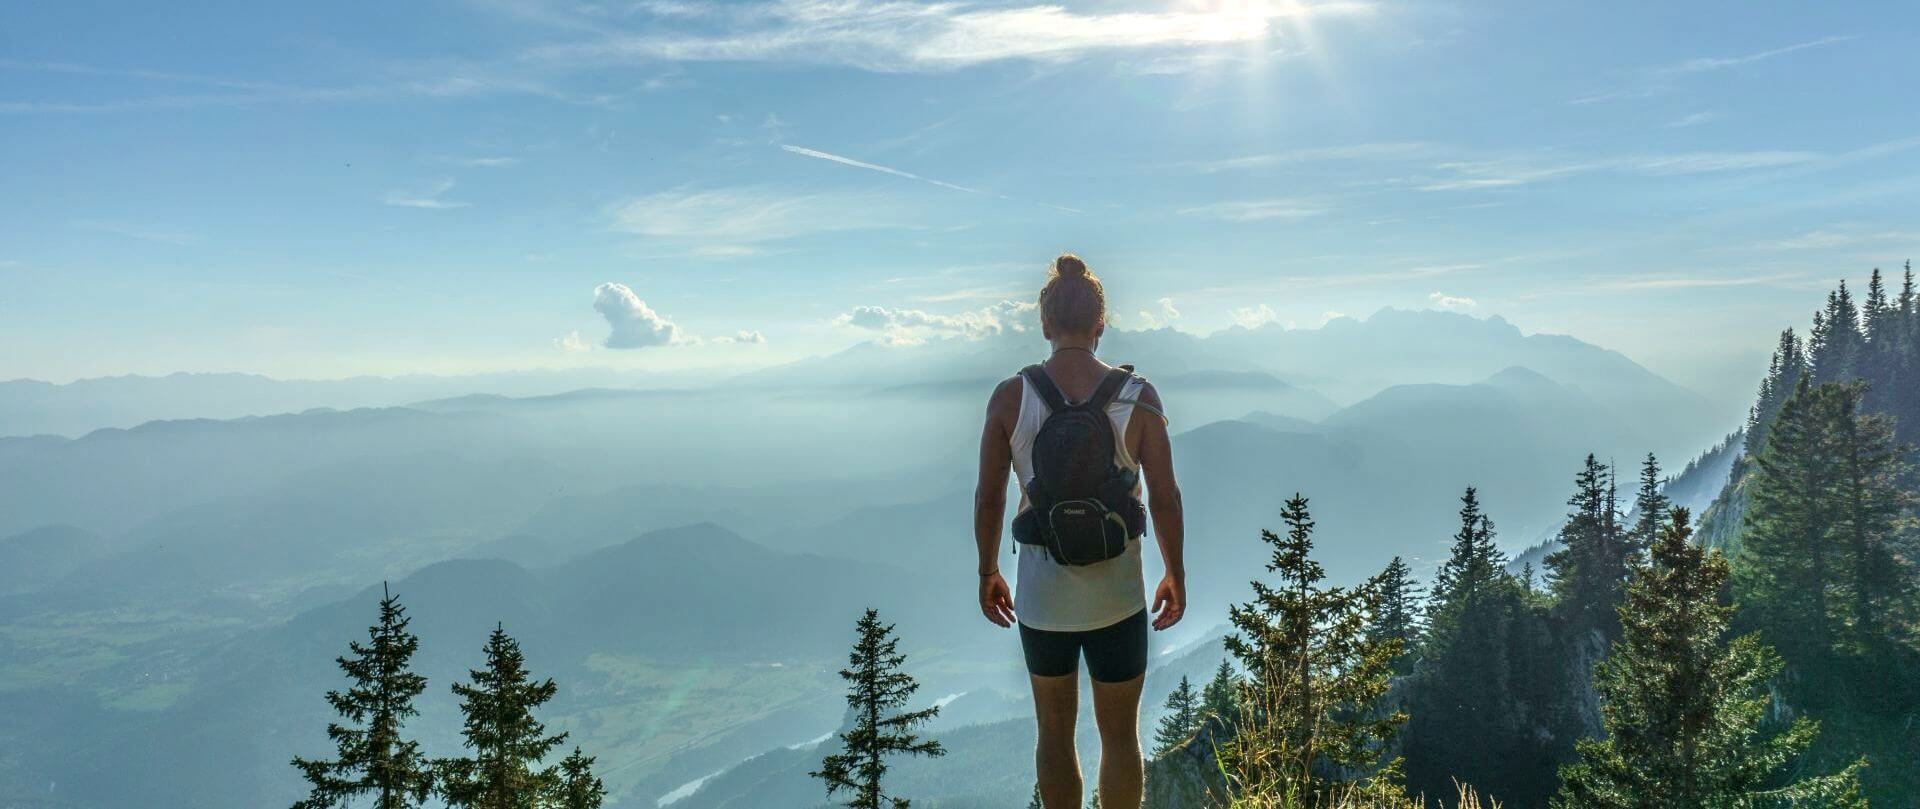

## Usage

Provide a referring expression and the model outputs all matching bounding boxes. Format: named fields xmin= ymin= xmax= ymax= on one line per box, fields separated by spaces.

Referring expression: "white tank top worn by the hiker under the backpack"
xmin=1012 ymin=377 xmax=1146 ymax=632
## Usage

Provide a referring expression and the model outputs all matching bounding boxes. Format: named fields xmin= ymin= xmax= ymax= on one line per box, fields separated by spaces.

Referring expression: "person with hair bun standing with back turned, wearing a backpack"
xmin=973 ymin=256 xmax=1187 ymax=809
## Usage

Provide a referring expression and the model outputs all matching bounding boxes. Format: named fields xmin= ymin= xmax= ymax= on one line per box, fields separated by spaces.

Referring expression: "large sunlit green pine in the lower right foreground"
xmin=1553 ymin=509 xmax=1866 ymax=809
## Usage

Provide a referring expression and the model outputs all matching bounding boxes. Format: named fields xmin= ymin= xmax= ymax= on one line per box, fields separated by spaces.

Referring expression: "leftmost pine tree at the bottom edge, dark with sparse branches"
xmin=294 ymin=582 xmax=432 ymax=809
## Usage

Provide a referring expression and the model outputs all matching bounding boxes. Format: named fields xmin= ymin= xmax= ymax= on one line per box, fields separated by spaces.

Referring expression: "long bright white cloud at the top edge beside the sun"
xmin=528 ymin=0 xmax=1373 ymax=73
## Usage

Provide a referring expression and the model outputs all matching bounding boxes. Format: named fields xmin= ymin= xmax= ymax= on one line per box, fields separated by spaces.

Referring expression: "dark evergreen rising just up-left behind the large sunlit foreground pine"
xmin=1546 ymin=455 xmax=1628 ymax=642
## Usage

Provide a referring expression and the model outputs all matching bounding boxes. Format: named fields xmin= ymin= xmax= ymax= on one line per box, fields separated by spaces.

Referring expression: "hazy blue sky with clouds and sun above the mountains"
xmin=0 ymin=0 xmax=1920 ymax=403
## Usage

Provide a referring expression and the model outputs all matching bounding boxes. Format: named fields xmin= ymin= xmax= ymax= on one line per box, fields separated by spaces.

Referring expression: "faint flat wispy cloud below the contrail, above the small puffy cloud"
xmin=611 ymin=186 xmax=904 ymax=239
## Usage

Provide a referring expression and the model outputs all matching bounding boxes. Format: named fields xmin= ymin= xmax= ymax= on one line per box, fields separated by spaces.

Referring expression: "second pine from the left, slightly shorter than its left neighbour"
xmin=440 ymin=625 xmax=566 ymax=809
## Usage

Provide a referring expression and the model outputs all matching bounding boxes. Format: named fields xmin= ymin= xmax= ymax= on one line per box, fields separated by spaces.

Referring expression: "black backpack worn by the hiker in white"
xmin=1014 ymin=365 xmax=1146 ymax=565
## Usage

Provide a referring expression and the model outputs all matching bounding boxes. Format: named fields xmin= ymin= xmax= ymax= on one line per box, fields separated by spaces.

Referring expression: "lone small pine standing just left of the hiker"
xmin=808 ymin=609 xmax=947 ymax=809
